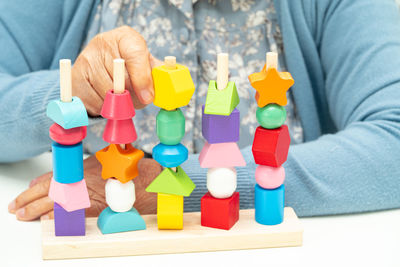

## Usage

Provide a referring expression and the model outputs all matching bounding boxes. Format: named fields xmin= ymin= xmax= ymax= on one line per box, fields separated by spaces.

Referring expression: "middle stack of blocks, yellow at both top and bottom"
xmin=146 ymin=56 xmax=195 ymax=229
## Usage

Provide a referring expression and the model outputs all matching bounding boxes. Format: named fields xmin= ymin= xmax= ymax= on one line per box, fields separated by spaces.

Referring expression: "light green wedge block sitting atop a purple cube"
xmin=204 ymin=80 xmax=240 ymax=116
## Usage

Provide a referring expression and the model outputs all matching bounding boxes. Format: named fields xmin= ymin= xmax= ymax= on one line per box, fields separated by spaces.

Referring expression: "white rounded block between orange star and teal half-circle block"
xmin=105 ymin=179 xmax=136 ymax=212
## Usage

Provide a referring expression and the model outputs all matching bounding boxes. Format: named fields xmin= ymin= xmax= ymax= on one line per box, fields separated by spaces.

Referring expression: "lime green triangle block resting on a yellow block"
xmin=146 ymin=167 xmax=196 ymax=197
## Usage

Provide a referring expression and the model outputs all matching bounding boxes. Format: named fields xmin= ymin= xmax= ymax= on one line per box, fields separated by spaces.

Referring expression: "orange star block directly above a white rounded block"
xmin=96 ymin=144 xmax=144 ymax=183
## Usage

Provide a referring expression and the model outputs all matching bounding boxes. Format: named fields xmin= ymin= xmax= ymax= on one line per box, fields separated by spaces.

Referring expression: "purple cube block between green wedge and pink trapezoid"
xmin=202 ymin=105 xmax=240 ymax=144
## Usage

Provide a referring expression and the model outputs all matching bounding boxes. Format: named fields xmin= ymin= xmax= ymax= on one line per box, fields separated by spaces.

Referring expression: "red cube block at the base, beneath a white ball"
xmin=201 ymin=192 xmax=239 ymax=230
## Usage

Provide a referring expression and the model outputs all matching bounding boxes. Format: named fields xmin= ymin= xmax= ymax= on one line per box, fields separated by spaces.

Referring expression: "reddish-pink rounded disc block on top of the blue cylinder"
xmin=49 ymin=123 xmax=87 ymax=146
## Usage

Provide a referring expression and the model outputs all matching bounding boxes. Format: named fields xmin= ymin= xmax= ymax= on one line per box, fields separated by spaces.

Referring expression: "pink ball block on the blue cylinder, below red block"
xmin=255 ymin=165 xmax=285 ymax=189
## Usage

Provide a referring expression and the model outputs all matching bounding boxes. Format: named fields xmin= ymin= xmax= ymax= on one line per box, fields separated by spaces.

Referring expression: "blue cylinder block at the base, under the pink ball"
xmin=254 ymin=185 xmax=285 ymax=225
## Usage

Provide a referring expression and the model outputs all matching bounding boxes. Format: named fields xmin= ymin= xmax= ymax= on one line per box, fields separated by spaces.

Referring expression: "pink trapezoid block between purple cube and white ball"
xmin=199 ymin=142 xmax=246 ymax=168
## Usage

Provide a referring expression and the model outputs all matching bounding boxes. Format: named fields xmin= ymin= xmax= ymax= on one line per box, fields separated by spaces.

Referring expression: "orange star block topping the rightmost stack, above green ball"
xmin=249 ymin=65 xmax=294 ymax=108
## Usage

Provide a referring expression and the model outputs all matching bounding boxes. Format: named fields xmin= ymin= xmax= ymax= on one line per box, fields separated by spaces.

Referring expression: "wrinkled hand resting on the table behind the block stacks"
xmin=8 ymin=156 xmax=162 ymax=221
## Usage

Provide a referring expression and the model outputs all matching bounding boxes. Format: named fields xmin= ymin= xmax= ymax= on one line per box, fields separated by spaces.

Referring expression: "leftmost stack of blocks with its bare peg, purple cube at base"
xmin=46 ymin=59 xmax=90 ymax=236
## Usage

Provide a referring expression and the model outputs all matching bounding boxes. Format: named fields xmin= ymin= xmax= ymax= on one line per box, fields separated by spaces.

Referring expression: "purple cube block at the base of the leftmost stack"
xmin=54 ymin=203 xmax=85 ymax=236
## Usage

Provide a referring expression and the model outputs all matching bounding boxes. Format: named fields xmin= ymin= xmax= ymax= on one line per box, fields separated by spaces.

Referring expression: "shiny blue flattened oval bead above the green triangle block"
xmin=153 ymin=144 xmax=189 ymax=168
